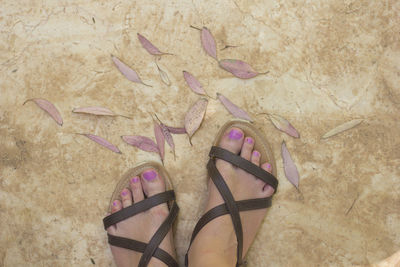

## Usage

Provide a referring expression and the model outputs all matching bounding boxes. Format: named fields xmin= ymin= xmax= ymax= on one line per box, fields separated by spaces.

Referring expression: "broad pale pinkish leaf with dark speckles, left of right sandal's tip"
xmin=185 ymin=98 xmax=208 ymax=143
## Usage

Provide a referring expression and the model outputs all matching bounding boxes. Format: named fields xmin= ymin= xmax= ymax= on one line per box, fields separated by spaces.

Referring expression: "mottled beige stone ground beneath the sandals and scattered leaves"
xmin=0 ymin=0 xmax=400 ymax=267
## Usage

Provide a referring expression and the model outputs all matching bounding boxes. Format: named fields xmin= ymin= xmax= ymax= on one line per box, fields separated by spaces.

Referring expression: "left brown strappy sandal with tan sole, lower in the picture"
xmin=103 ymin=162 xmax=179 ymax=267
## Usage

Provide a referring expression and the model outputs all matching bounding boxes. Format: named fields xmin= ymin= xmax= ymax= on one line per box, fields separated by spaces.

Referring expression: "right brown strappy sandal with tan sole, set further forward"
xmin=185 ymin=120 xmax=278 ymax=266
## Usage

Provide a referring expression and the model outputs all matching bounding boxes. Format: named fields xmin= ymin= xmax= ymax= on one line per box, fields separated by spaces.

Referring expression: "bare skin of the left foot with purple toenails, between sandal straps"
xmin=107 ymin=169 xmax=176 ymax=267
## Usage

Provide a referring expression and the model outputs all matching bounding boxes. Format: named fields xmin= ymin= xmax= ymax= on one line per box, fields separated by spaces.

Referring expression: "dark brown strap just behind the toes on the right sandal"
xmin=209 ymin=146 xmax=278 ymax=192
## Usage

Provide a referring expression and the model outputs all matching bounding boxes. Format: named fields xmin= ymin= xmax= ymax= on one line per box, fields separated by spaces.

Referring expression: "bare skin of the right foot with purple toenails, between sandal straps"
xmin=189 ymin=127 xmax=274 ymax=267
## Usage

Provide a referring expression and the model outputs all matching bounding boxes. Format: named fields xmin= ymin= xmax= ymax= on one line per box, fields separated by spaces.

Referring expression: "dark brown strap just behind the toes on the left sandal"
xmin=103 ymin=190 xmax=175 ymax=229
